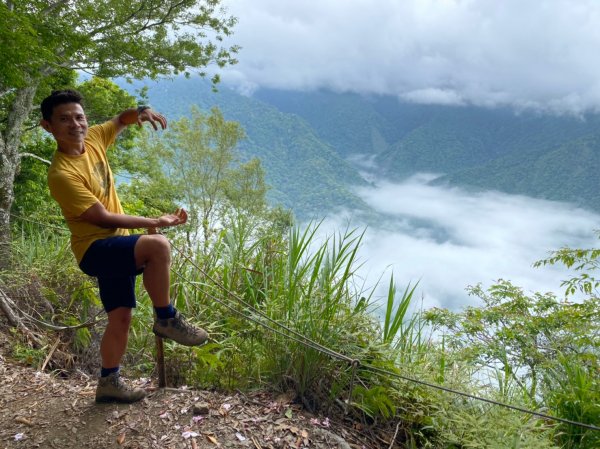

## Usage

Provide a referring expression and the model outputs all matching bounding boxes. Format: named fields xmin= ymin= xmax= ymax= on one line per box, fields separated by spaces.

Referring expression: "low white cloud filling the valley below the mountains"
xmin=316 ymin=175 xmax=600 ymax=309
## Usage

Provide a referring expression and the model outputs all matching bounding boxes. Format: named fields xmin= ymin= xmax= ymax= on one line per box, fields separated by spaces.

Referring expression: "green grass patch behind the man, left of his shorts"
xmin=0 ymin=221 xmax=101 ymax=369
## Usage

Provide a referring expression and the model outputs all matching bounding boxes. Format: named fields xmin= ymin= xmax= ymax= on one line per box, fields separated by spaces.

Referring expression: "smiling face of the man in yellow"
xmin=40 ymin=103 xmax=88 ymax=149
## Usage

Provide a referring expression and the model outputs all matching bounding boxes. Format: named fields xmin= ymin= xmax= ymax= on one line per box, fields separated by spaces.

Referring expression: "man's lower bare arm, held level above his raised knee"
xmin=80 ymin=202 xmax=187 ymax=229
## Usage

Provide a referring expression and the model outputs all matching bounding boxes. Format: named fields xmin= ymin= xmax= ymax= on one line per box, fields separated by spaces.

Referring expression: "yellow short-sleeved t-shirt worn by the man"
xmin=48 ymin=121 xmax=129 ymax=263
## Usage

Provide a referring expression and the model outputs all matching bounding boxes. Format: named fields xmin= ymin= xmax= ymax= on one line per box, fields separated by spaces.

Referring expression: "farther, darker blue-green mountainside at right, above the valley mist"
xmin=255 ymin=90 xmax=600 ymax=214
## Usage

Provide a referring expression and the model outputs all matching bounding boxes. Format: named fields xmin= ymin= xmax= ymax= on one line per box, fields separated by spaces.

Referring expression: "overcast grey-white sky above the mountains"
xmin=224 ymin=0 xmax=600 ymax=113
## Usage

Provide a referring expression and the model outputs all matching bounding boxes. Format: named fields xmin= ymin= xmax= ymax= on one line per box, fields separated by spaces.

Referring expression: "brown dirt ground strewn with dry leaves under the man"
xmin=0 ymin=354 xmax=388 ymax=449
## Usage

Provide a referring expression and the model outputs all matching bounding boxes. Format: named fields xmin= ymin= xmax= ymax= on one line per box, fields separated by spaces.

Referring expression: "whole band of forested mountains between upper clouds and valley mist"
xmin=120 ymin=78 xmax=600 ymax=217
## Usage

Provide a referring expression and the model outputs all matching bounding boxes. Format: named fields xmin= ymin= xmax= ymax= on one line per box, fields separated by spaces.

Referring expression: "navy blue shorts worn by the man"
xmin=79 ymin=235 xmax=144 ymax=313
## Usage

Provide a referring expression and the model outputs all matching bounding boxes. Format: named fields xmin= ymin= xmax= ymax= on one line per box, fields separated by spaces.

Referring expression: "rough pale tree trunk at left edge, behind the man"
xmin=0 ymin=82 xmax=38 ymax=271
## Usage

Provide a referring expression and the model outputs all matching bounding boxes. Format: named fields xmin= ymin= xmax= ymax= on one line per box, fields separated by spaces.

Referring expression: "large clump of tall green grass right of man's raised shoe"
xmin=133 ymin=220 xmax=426 ymax=402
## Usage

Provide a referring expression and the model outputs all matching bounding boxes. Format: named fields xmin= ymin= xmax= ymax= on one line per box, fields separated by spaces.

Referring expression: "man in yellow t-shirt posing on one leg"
xmin=40 ymin=90 xmax=208 ymax=402
